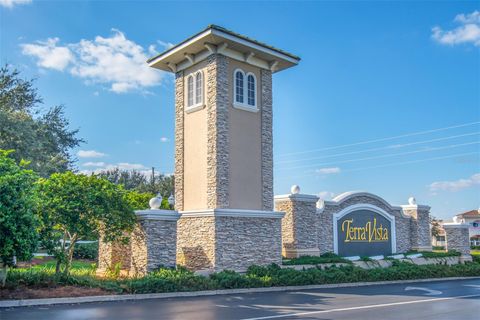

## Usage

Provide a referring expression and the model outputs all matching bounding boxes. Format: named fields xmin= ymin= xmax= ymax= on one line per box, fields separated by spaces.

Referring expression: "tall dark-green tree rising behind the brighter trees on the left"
xmin=0 ymin=66 xmax=83 ymax=177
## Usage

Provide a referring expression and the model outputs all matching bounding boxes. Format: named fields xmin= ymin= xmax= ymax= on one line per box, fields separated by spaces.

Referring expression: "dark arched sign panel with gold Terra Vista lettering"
xmin=335 ymin=209 xmax=394 ymax=256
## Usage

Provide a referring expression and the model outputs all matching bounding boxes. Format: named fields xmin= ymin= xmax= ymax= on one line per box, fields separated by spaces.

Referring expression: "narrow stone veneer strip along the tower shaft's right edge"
xmin=260 ymin=69 xmax=273 ymax=211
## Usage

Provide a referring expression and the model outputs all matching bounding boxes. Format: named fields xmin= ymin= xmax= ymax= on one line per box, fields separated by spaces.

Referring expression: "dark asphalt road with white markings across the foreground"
xmin=0 ymin=279 xmax=480 ymax=320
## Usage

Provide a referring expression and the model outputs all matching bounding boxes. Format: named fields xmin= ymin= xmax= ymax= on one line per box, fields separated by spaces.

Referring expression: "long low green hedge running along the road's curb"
xmin=7 ymin=261 xmax=480 ymax=293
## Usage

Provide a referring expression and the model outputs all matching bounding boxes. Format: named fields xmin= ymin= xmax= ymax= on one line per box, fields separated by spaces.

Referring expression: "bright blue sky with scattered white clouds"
xmin=0 ymin=0 xmax=480 ymax=218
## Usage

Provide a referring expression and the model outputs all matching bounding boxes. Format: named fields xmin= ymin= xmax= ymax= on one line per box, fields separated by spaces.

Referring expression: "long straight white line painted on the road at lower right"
xmin=241 ymin=294 xmax=480 ymax=320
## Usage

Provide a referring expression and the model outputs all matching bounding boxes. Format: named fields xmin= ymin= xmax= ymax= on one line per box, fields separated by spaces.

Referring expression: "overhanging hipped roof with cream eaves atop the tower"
xmin=147 ymin=25 xmax=300 ymax=72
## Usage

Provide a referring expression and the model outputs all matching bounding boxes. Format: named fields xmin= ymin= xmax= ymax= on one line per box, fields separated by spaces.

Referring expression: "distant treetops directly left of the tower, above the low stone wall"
xmin=98 ymin=168 xmax=174 ymax=198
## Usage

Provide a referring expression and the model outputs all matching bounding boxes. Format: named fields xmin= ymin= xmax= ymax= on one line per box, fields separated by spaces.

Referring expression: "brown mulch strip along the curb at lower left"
xmin=0 ymin=286 xmax=113 ymax=300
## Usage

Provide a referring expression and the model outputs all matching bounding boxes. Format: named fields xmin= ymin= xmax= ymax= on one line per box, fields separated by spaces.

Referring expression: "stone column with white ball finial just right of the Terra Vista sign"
xmin=402 ymin=197 xmax=432 ymax=251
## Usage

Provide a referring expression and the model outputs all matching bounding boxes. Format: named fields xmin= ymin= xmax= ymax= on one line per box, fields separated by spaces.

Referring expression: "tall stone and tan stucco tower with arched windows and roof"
xmin=148 ymin=25 xmax=300 ymax=270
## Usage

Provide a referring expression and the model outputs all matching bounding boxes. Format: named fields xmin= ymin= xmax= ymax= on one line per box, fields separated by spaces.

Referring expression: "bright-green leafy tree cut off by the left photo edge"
xmin=0 ymin=150 xmax=37 ymax=286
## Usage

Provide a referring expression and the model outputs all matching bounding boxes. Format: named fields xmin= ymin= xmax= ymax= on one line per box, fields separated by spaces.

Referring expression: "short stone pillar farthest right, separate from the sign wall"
xmin=443 ymin=223 xmax=472 ymax=261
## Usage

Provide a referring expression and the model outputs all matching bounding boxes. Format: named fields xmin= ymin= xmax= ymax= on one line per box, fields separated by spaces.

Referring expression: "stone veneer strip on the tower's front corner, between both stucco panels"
xmin=207 ymin=54 xmax=229 ymax=209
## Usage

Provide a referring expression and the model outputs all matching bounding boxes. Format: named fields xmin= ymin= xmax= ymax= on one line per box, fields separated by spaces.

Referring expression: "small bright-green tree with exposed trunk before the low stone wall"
xmin=38 ymin=172 xmax=136 ymax=274
